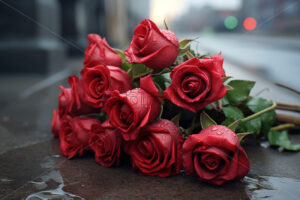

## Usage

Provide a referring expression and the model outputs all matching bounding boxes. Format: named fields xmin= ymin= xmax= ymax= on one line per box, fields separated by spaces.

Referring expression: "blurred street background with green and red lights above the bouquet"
xmin=0 ymin=0 xmax=300 ymax=108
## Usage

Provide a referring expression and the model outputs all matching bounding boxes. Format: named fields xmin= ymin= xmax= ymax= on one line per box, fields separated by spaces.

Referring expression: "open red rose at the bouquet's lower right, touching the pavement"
xmin=182 ymin=125 xmax=249 ymax=185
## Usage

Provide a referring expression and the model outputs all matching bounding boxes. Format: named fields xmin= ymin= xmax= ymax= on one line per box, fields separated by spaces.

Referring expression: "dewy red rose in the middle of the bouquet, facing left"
xmin=105 ymin=88 xmax=161 ymax=141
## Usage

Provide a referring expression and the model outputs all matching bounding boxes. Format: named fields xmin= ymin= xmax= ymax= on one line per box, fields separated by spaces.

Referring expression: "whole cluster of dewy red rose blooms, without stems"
xmin=51 ymin=19 xmax=249 ymax=185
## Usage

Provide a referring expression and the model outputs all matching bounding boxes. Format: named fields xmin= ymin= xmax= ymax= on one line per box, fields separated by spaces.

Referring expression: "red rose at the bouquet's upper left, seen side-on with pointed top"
xmin=83 ymin=34 xmax=122 ymax=67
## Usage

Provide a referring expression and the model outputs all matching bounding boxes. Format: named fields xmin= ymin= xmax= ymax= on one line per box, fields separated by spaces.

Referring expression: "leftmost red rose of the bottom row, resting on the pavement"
xmin=59 ymin=115 xmax=101 ymax=159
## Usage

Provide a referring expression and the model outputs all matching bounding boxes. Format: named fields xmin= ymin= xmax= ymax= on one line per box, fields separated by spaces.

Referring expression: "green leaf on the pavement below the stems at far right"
xmin=268 ymin=130 xmax=300 ymax=151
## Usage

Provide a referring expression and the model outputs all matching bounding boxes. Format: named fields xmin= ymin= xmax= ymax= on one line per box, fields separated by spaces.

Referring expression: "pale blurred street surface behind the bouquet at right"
xmin=184 ymin=34 xmax=300 ymax=91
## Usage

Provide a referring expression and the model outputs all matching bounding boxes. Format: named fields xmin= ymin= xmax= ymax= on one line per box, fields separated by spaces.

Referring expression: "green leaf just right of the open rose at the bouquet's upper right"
xmin=226 ymin=80 xmax=255 ymax=103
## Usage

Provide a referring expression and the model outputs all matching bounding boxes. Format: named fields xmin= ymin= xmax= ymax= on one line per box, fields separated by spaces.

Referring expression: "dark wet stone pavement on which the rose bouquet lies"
xmin=0 ymin=58 xmax=300 ymax=200
